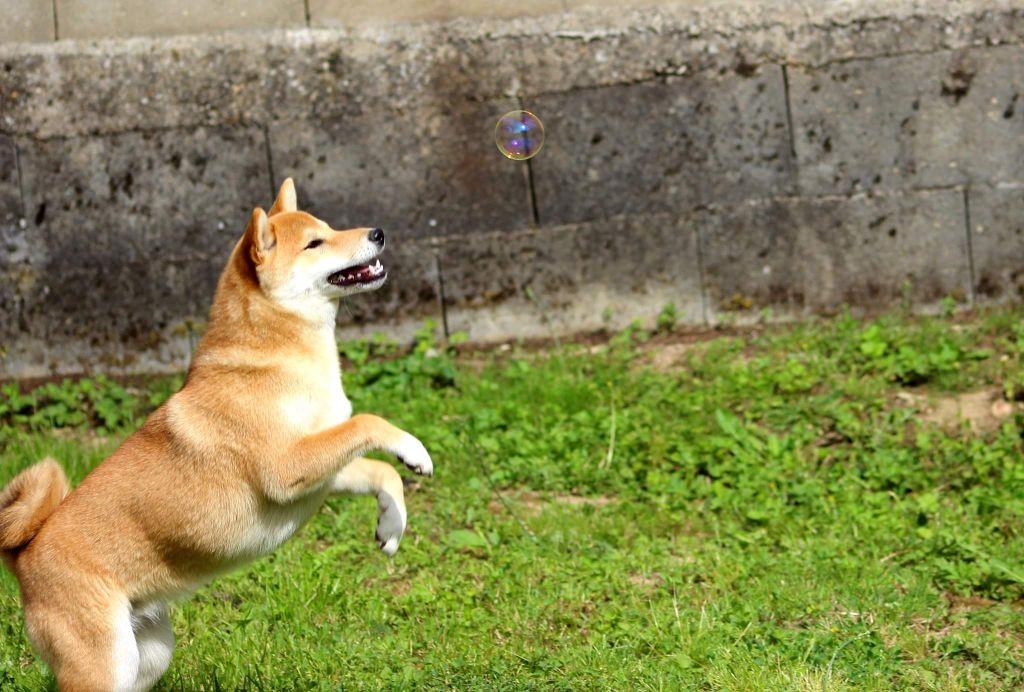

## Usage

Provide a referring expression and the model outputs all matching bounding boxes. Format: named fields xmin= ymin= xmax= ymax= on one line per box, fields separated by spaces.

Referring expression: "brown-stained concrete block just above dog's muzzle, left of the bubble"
xmin=270 ymin=95 xmax=530 ymax=239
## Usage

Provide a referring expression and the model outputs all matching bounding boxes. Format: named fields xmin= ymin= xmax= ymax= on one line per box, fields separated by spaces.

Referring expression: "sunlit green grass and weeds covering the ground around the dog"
xmin=0 ymin=309 xmax=1024 ymax=690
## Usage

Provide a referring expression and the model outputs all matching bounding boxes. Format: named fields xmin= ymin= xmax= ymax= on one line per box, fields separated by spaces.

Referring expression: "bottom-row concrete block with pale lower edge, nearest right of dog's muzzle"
xmin=437 ymin=214 xmax=703 ymax=340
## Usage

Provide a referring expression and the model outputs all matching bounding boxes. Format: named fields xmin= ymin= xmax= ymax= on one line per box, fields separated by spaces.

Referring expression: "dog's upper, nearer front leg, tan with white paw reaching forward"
xmin=260 ymin=414 xmax=434 ymax=504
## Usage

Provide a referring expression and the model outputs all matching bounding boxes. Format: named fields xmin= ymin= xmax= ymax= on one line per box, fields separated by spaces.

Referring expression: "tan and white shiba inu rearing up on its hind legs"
xmin=0 ymin=179 xmax=433 ymax=691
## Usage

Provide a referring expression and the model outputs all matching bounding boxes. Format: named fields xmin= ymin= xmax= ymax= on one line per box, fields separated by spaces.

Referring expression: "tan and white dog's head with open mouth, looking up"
xmin=244 ymin=178 xmax=387 ymax=305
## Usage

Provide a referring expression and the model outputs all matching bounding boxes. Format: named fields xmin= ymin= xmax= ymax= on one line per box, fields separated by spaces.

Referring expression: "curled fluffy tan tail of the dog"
xmin=0 ymin=459 xmax=69 ymax=552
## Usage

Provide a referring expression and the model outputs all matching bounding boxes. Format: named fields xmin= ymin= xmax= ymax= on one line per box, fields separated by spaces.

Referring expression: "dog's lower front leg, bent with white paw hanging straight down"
xmin=331 ymin=457 xmax=408 ymax=556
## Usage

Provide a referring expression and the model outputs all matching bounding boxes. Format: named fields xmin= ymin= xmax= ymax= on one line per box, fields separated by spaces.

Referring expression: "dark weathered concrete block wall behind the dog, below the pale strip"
xmin=0 ymin=0 xmax=1024 ymax=377
